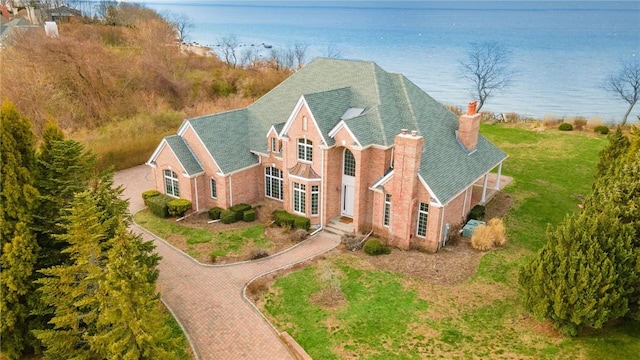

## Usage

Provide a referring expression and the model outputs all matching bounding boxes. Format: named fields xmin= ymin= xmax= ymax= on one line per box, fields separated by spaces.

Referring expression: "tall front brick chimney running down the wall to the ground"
xmin=389 ymin=129 xmax=424 ymax=249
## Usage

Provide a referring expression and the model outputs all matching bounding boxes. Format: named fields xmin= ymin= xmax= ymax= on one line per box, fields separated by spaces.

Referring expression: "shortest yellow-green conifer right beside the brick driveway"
xmin=91 ymin=221 xmax=177 ymax=360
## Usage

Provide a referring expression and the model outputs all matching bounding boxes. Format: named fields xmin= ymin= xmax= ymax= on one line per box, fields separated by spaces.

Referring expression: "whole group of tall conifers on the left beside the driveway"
xmin=0 ymin=101 xmax=179 ymax=359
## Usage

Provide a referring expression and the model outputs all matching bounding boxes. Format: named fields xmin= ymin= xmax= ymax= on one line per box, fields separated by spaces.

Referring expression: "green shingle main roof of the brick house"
xmin=170 ymin=58 xmax=506 ymax=203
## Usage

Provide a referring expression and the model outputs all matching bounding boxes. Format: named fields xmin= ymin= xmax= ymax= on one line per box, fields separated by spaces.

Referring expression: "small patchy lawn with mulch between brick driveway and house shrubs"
xmin=134 ymin=210 xmax=293 ymax=264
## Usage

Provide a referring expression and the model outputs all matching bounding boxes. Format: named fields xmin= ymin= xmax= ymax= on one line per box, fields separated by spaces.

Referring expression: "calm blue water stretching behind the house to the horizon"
xmin=145 ymin=1 xmax=640 ymax=121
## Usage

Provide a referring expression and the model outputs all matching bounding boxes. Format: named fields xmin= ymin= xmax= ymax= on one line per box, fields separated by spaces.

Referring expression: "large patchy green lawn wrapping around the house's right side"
xmin=264 ymin=125 xmax=640 ymax=359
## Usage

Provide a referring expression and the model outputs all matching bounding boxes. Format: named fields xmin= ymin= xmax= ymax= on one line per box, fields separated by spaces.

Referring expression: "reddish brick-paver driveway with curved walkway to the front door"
xmin=114 ymin=165 xmax=340 ymax=360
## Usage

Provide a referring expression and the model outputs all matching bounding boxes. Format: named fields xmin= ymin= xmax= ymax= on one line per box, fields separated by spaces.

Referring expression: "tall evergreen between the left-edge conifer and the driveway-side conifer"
xmin=34 ymin=191 xmax=107 ymax=359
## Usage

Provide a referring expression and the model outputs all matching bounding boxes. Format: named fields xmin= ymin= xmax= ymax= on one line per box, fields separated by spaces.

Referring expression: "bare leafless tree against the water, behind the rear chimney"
xmin=460 ymin=42 xmax=514 ymax=111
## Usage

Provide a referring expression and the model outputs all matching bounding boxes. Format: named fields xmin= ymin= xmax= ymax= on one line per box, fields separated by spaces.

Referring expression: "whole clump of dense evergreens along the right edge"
xmin=519 ymin=127 xmax=640 ymax=335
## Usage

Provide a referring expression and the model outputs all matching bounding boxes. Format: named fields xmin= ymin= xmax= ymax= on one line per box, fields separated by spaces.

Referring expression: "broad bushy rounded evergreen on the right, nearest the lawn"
xmin=519 ymin=206 xmax=638 ymax=335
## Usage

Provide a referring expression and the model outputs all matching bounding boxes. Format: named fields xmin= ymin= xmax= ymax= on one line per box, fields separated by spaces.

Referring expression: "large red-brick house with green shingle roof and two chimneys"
xmin=147 ymin=58 xmax=507 ymax=251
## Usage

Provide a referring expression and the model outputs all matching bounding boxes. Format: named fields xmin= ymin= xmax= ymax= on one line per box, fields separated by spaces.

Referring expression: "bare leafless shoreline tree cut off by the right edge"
xmin=604 ymin=60 xmax=640 ymax=126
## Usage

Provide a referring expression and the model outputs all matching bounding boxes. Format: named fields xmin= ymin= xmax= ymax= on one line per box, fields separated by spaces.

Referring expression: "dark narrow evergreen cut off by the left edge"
xmin=0 ymin=101 xmax=38 ymax=359
